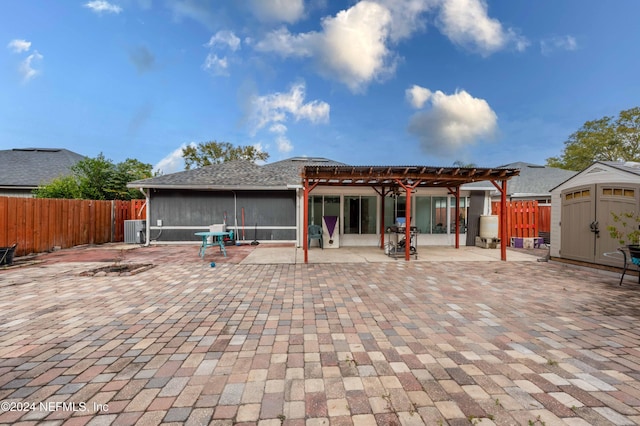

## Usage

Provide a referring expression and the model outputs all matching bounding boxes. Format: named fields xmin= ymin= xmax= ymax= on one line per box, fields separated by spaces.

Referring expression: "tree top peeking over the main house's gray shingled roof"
xmin=182 ymin=141 xmax=269 ymax=170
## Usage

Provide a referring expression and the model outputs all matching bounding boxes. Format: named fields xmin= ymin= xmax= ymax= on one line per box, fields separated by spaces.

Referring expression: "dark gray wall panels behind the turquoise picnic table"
xmin=149 ymin=189 xmax=296 ymax=242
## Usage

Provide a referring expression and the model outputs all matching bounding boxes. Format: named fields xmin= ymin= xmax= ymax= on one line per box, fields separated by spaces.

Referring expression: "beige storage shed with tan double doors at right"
xmin=551 ymin=161 xmax=640 ymax=266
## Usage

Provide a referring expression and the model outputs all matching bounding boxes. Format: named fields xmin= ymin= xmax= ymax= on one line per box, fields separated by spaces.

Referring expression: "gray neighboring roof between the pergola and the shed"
xmin=463 ymin=161 xmax=578 ymax=197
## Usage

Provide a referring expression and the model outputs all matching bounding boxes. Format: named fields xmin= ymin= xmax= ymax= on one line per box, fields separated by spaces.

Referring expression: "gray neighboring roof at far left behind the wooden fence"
xmin=0 ymin=148 xmax=85 ymax=189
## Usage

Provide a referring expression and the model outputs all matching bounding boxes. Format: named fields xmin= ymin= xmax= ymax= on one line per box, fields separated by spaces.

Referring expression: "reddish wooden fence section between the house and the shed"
xmin=491 ymin=201 xmax=551 ymax=243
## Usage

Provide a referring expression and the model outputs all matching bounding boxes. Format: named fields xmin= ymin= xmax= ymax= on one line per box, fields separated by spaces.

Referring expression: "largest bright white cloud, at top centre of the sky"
xmin=256 ymin=1 xmax=395 ymax=92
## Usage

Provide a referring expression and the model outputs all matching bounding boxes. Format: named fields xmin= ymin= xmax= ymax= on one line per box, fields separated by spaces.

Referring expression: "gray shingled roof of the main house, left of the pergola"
xmin=127 ymin=157 xmax=344 ymax=190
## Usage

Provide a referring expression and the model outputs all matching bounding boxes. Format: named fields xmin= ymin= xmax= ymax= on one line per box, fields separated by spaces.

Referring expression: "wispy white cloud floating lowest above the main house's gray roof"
xmin=251 ymin=83 xmax=330 ymax=134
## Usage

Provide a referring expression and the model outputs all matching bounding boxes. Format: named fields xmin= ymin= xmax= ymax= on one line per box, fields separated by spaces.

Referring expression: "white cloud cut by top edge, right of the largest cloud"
xmin=438 ymin=0 xmax=529 ymax=56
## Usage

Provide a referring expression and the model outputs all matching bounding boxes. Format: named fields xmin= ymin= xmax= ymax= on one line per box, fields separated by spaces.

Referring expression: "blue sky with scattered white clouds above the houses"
xmin=0 ymin=0 xmax=640 ymax=173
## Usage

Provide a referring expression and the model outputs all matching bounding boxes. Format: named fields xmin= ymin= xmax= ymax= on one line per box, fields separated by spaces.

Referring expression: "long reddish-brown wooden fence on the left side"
xmin=0 ymin=197 xmax=146 ymax=256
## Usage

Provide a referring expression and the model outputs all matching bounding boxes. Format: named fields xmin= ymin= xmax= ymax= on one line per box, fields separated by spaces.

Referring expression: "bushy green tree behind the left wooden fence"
xmin=33 ymin=153 xmax=153 ymax=200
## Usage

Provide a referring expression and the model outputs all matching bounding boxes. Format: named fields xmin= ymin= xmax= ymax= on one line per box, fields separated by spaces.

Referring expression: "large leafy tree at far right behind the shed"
xmin=547 ymin=107 xmax=640 ymax=170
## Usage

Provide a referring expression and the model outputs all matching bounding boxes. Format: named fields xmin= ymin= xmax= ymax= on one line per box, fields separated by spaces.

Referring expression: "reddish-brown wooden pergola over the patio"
xmin=302 ymin=166 xmax=520 ymax=263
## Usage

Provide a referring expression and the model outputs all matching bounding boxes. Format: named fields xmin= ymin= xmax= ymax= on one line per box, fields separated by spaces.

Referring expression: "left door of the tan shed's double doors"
xmin=560 ymin=185 xmax=596 ymax=262
